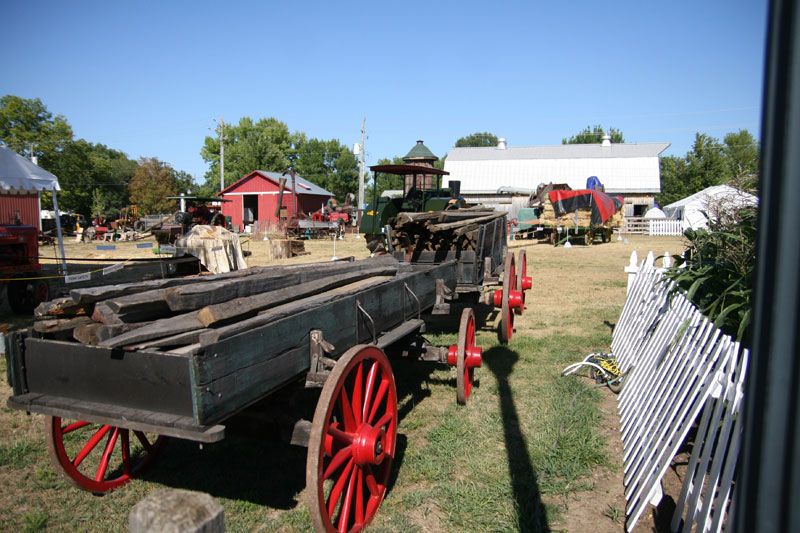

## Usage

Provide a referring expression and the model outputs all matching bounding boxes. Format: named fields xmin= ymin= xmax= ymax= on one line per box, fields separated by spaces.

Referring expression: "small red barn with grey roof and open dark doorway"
xmin=218 ymin=170 xmax=333 ymax=228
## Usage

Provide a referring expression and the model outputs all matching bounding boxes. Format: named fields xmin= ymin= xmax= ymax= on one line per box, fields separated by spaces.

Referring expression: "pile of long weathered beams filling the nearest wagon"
xmin=33 ymin=256 xmax=402 ymax=353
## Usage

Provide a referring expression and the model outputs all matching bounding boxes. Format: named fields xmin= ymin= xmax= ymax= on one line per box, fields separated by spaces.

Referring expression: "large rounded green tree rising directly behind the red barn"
xmin=200 ymin=117 xmax=300 ymax=195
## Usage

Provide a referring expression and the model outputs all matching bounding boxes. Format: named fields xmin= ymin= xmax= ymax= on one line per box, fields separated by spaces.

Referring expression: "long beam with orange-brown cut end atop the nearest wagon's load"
xmin=197 ymin=264 xmax=398 ymax=327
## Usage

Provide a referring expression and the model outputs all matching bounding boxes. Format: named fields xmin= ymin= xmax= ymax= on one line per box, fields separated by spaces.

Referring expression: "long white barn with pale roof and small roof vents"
xmin=444 ymin=136 xmax=670 ymax=218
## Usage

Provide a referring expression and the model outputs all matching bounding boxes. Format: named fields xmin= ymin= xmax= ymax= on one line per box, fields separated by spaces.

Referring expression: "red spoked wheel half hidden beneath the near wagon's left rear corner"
xmin=45 ymin=416 xmax=167 ymax=494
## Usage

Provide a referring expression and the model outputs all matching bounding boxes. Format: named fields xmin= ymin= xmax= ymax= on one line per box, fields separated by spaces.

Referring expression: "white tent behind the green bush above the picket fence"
xmin=664 ymin=185 xmax=758 ymax=230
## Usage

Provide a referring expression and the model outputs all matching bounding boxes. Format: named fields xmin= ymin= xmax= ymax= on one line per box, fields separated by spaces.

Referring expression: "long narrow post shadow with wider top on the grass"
xmin=483 ymin=346 xmax=550 ymax=533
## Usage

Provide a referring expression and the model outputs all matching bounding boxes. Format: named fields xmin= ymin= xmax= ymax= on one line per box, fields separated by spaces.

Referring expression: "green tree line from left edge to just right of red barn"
xmin=0 ymin=95 xmax=358 ymax=218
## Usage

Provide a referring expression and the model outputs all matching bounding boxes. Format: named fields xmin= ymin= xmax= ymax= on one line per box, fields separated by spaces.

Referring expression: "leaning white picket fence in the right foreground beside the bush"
xmin=611 ymin=252 xmax=748 ymax=532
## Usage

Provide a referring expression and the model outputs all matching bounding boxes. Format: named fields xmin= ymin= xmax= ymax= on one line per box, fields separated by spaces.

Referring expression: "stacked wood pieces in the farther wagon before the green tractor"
xmin=389 ymin=206 xmax=506 ymax=253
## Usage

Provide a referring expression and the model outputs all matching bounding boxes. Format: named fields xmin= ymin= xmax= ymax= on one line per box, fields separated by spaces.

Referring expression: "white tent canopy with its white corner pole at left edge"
xmin=0 ymin=145 xmax=67 ymax=270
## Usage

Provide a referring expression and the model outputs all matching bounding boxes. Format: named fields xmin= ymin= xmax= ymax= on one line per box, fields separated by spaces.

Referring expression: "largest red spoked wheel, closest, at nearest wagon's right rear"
xmin=306 ymin=345 xmax=397 ymax=532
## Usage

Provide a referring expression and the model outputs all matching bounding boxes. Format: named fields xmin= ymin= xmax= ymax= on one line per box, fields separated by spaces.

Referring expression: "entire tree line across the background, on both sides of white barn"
xmin=0 ymin=95 xmax=759 ymax=217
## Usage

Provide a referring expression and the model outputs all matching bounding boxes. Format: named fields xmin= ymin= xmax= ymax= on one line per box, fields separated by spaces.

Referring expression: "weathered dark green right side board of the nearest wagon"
xmin=192 ymin=261 xmax=456 ymax=424
